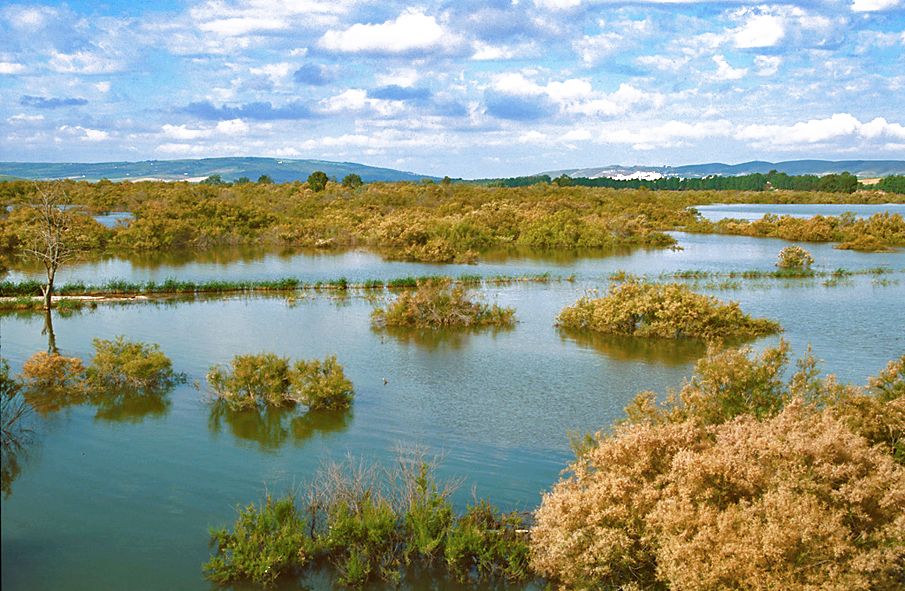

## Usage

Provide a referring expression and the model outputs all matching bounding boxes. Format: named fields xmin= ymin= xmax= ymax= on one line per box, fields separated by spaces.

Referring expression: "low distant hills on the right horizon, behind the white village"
xmin=544 ymin=160 xmax=905 ymax=179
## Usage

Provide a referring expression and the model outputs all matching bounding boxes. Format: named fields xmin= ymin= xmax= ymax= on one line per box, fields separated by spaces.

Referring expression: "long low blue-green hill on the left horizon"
xmin=0 ymin=158 xmax=434 ymax=183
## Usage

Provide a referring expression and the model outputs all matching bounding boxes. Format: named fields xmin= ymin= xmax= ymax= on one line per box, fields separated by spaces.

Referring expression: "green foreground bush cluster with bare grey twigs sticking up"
xmin=204 ymin=460 xmax=530 ymax=588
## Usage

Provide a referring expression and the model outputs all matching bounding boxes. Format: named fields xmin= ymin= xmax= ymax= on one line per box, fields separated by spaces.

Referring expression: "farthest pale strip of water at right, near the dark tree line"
xmin=695 ymin=203 xmax=905 ymax=222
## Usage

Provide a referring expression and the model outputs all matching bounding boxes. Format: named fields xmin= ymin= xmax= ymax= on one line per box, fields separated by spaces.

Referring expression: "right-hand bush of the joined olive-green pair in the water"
xmin=289 ymin=355 xmax=355 ymax=410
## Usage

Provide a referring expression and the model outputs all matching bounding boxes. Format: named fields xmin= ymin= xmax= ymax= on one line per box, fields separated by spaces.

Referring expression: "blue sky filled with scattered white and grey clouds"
xmin=0 ymin=0 xmax=905 ymax=178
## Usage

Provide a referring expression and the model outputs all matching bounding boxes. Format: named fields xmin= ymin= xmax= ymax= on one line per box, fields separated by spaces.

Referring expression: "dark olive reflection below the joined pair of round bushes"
xmin=207 ymin=400 xmax=352 ymax=451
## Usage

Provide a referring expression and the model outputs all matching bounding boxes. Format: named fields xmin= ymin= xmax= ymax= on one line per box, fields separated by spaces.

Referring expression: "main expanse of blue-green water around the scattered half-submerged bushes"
xmin=0 ymin=212 xmax=905 ymax=590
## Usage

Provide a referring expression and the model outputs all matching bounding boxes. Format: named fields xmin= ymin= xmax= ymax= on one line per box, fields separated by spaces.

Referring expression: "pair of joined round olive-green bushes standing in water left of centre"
xmin=207 ymin=353 xmax=354 ymax=410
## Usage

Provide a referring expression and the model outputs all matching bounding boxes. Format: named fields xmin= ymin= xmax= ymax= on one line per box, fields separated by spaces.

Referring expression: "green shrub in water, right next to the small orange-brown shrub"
xmin=87 ymin=336 xmax=179 ymax=393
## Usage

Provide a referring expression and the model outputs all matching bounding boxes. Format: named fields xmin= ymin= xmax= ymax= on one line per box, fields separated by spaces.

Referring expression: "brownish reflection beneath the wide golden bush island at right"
xmin=559 ymin=328 xmax=707 ymax=367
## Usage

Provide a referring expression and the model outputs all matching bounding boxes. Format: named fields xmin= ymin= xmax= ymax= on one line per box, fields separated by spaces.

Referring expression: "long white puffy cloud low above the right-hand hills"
xmin=736 ymin=113 xmax=905 ymax=148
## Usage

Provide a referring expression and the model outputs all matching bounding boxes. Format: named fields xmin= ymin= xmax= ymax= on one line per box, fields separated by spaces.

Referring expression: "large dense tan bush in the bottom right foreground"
xmin=532 ymin=347 xmax=905 ymax=591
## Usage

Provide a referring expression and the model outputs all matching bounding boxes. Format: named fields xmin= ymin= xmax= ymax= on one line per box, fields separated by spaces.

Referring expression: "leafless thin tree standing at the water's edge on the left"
xmin=23 ymin=183 xmax=76 ymax=310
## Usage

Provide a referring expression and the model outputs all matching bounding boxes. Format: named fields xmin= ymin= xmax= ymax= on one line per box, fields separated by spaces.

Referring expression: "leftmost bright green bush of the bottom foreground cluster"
xmin=204 ymin=496 xmax=312 ymax=586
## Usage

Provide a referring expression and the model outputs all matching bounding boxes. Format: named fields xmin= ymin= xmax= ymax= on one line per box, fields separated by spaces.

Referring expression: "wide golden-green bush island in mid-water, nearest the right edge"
xmin=557 ymin=279 xmax=781 ymax=340
